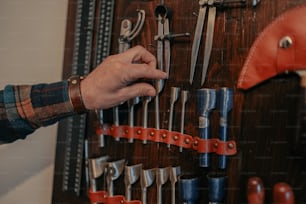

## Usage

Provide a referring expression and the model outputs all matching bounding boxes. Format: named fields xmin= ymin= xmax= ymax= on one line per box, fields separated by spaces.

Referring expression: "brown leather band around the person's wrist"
xmin=68 ymin=75 xmax=87 ymax=113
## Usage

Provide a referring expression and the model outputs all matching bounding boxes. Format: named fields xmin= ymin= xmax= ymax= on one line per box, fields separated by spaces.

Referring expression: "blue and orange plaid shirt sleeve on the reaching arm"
xmin=0 ymin=81 xmax=75 ymax=143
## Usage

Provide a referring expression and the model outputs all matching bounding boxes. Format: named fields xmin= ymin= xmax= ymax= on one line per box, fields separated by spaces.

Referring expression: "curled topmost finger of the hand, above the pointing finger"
xmin=119 ymin=45 xmax=156 ymax=69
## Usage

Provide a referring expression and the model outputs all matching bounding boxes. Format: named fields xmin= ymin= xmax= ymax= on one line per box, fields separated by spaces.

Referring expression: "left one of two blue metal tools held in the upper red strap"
xmin=197 ymin=88 xmax=216 ymax=167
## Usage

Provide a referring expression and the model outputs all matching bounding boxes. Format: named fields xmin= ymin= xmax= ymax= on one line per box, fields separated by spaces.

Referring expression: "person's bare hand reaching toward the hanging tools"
xmin=81 ymin=46 xmax=167 ymax=110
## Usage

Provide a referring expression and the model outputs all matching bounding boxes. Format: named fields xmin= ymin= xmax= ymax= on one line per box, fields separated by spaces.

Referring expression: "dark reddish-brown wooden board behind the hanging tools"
xmin=53 ymin=0 xmax=306 ymax=204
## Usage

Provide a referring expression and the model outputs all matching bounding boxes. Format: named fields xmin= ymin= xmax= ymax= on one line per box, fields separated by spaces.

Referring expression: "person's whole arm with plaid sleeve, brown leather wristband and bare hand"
xmin=0 ymin=46 xmax=167 ymax=142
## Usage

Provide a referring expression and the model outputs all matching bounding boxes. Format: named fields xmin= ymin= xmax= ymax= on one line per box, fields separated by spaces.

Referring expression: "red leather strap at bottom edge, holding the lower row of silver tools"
xmin=88 ymin=190 xmax=141 ymax=204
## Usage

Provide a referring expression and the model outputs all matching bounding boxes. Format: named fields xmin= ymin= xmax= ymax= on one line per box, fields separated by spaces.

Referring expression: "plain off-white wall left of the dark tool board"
xmin=0 ymin=0 xmax=68 ymax=204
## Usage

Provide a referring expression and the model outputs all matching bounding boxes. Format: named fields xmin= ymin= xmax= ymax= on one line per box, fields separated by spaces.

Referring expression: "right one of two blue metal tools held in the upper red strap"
xmin=217 ymin=87 xmax=233 ymax=169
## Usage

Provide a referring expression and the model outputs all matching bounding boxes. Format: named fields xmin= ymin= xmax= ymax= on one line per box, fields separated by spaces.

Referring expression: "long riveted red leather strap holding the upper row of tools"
xmin=96 ymin=125 xmax=237 ymax=155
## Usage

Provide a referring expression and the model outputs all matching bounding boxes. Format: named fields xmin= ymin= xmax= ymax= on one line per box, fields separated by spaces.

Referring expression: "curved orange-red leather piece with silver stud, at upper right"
xmin=237 ymin=4 xmax=306 ymax=89
